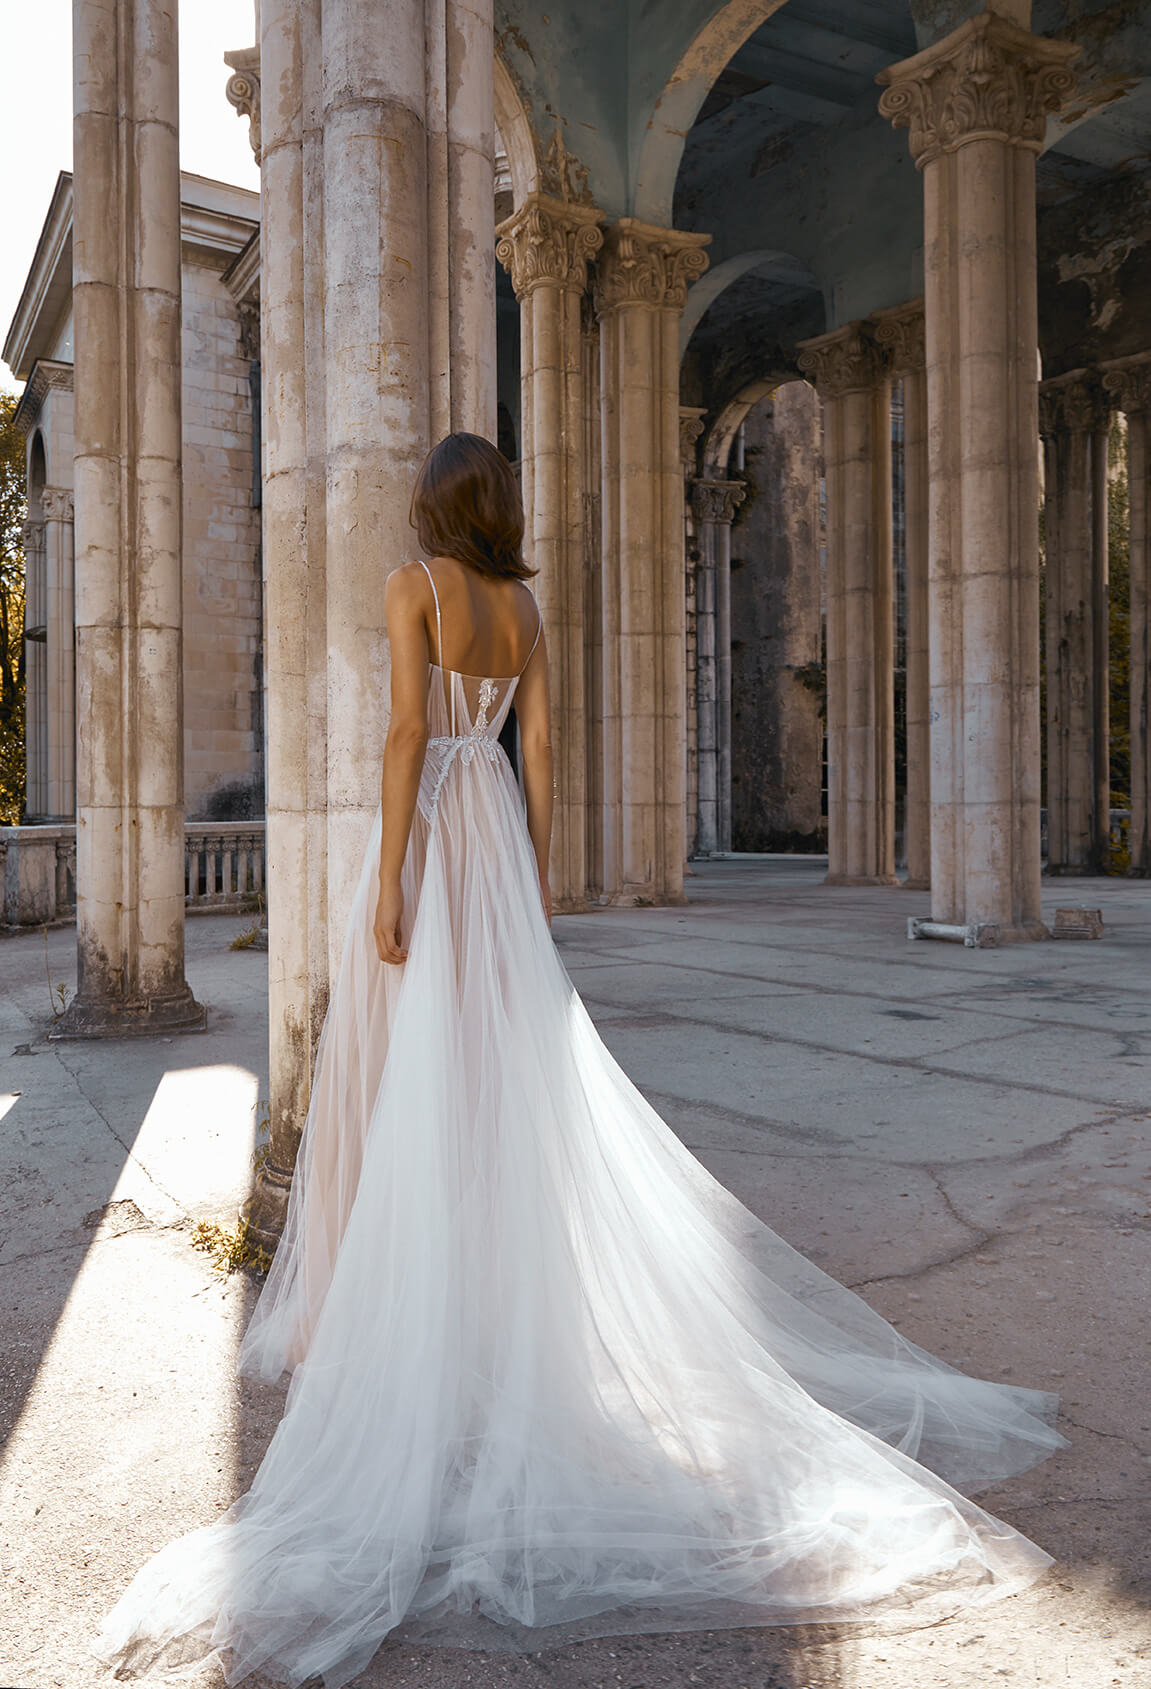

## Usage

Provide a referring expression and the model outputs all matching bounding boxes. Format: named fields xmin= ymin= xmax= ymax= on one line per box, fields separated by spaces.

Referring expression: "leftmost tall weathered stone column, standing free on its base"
xmin=54 ymin=0 xmax=205 ymax=1037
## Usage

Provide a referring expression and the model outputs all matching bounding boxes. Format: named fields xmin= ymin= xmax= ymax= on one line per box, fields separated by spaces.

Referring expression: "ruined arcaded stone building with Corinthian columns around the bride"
xmin=6 ymin=0 xmax=1151 ymax=1236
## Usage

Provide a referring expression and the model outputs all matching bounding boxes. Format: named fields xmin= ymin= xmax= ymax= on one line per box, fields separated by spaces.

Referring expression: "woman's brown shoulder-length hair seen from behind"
xmin=411 ymin=434 xmax=536 ymax=581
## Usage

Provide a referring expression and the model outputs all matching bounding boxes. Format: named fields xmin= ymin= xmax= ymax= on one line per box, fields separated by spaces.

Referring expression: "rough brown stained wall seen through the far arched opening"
xmin=732 ymin=382 xmax=825 ymax=851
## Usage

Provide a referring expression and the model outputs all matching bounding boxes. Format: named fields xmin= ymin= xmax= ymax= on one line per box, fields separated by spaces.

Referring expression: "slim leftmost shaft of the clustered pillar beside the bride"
xmin=245 ymin=0 xmax=328 ymax=1248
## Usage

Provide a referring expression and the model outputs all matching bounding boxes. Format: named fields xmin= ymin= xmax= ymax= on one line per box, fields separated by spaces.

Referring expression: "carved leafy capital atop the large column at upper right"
xmin=876 ymin=12 xmax=1080 ymax=169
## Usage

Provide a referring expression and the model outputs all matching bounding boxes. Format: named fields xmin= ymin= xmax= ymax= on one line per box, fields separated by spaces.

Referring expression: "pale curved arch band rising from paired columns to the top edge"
xmin=632 ymin=0 xmax=784 ymax=226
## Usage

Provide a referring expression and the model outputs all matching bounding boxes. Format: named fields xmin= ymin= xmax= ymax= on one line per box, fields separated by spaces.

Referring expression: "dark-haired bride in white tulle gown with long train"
xmin=96 ymin=434 xmax=1063 ymax=1689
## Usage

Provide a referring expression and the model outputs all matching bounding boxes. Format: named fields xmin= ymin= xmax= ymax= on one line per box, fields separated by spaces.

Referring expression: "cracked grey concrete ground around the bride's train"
xmin=0 ymin=858 xmax=1151 ymax=1689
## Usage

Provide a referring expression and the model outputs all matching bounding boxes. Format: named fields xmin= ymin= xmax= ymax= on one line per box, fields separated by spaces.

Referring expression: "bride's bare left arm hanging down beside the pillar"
xmin=374 ymin=566 xmax=429 ymax=963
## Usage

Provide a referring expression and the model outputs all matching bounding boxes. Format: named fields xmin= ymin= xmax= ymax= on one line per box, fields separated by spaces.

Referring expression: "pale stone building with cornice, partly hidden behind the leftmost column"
xmin=3 ymin=172 xmax=264 ymax=824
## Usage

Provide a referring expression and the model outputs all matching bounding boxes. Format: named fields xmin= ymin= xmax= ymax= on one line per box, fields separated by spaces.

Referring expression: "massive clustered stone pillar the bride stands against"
xmin=245 ymin=0 xmax=495 ymax=1240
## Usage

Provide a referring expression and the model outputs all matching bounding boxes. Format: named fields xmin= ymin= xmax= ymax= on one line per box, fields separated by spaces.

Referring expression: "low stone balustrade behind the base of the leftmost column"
xmin=0 ymin=821 xmax=265 ymax=927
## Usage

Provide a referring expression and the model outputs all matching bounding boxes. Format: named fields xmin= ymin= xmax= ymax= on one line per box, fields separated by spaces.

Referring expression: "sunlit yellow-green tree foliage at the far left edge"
xmin=0 ymin=392 xmax=27 ymax=826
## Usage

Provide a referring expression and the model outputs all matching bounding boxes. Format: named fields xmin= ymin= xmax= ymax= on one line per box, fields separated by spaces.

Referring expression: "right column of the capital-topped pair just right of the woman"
xmin=597 ymin=218 xmax=710 ymax=904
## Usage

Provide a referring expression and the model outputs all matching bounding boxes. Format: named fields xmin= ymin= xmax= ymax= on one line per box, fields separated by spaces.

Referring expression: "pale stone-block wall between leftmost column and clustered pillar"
xmin=183 ymin=252 xmax=264 ymax=821
